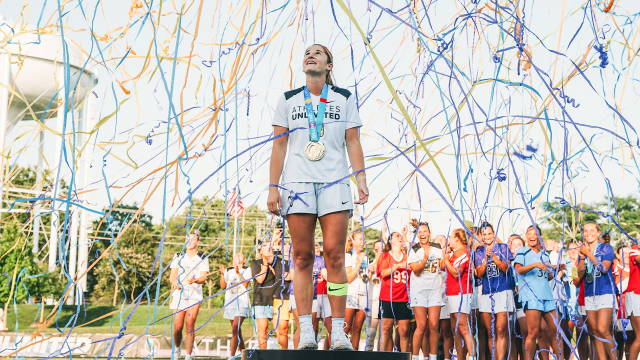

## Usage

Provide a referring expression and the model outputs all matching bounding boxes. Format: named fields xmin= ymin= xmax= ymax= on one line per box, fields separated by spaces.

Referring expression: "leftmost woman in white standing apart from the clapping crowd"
xmin=169 ymin=232 xmax=209 ymax=360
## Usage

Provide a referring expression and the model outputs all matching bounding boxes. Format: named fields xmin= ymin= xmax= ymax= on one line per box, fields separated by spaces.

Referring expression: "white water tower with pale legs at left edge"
xmin=0 ymin=16 xmax=98 ymax=303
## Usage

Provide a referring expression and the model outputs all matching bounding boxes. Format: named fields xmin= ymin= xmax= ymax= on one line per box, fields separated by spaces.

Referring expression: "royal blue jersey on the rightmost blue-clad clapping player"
xmin=580 ymin=242 xmax=618 ymax=296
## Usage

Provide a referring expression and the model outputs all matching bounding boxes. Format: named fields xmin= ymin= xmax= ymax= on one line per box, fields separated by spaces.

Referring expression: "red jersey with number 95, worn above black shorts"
xmin=376 ymin=252 xmax=409 ymax=302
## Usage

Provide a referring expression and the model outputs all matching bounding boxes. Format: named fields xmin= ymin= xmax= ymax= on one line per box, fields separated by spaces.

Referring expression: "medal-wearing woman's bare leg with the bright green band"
xmin=318 ymin=211 xmax=349 ymax=318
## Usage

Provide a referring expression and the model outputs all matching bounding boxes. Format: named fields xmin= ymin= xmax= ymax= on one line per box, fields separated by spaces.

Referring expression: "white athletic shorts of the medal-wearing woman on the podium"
xmin=280 ymin=182 xmax=353 ymax=217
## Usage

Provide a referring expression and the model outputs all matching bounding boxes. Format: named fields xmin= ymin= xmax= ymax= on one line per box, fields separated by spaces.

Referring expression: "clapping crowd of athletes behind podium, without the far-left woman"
xmin=219 ymin=220 xmax=640 ymax=360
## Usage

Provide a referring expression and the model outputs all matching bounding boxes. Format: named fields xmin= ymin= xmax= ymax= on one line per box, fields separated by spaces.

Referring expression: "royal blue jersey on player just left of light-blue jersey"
xmin=473 ymin=243 xmax=513 ymax=294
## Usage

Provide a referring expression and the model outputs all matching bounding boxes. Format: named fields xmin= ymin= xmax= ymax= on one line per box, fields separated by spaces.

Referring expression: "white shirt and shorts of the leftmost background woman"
xmin=169 ymin=253 xmax=209 ymax=310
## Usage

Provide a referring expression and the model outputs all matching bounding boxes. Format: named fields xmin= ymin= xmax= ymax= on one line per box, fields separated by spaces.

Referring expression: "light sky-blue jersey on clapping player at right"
xmin=513 ymin=246 xmax=553 ymax=302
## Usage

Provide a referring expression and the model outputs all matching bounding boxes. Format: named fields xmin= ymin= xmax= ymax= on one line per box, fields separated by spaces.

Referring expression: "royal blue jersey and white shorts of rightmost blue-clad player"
xmin=582 ymin=242 xmax=618 ymax=311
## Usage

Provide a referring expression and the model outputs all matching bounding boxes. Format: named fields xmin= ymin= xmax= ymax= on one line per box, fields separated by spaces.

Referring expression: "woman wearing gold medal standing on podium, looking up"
xmin=267 ymin=45 xmax=369 ymax=350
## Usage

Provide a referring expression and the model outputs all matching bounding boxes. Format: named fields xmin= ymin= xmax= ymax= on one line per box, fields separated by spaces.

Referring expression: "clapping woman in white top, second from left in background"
xmin=220 ymin=253 xmax=251 ymax=358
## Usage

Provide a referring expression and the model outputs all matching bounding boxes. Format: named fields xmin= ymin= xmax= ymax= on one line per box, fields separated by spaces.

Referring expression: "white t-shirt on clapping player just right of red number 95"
xmin=407 ymin=243 xmax=443 ymax=291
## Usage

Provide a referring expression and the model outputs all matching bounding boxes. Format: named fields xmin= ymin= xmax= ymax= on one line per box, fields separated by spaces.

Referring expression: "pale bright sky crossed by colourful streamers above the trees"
xmin=0 ymin=0 xmax=640 ymax=243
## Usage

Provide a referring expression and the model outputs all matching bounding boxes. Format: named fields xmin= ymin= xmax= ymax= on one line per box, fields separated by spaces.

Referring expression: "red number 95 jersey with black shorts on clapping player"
xmin=376 ymin=252 xmax=412 ymax=320
